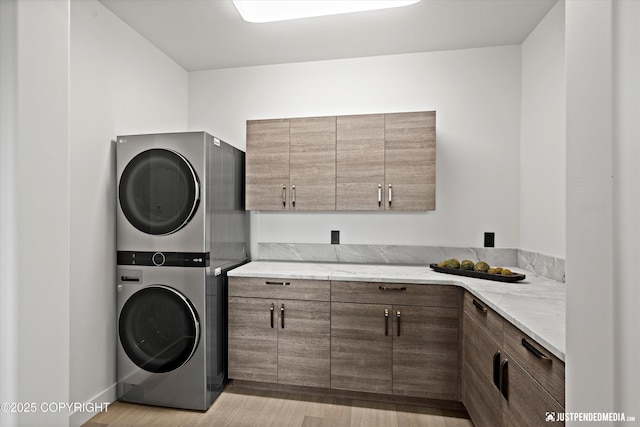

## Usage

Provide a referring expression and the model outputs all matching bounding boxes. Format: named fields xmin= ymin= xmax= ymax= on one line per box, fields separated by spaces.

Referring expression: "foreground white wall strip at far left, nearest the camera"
xmin=11 ymin=0 xmax=69 ymax=426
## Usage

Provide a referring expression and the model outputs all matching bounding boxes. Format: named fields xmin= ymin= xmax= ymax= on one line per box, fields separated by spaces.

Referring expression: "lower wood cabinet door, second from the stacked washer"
xmin=278 ymin=300 xmax=331 ymax=388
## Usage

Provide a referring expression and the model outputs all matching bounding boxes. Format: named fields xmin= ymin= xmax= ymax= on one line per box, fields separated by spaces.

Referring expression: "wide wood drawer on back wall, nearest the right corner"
xmin=331 ymin=281 xmax=460 ymax=307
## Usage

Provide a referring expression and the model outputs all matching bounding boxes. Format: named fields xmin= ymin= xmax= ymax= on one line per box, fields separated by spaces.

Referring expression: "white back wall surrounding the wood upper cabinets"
xmin=189 ymin=46 xmax=520 ymax=253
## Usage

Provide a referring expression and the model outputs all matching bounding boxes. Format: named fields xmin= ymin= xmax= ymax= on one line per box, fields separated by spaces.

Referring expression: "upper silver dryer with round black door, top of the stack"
xmin=116 ymin=132 xmax=247 ymax=267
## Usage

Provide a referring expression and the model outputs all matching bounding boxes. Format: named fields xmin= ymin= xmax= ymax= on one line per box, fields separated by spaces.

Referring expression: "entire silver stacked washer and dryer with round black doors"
xmin=116 ymin=132 xmax=247 ymax=410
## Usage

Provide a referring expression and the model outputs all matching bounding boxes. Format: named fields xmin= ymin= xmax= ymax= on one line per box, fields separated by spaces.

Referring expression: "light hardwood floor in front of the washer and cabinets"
xmin=83 ymin=384 xmax=473 ymax=427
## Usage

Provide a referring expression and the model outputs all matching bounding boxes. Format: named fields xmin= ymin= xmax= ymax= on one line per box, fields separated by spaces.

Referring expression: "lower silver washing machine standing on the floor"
xmin=117 ymin=265 xmax=234 ymax=411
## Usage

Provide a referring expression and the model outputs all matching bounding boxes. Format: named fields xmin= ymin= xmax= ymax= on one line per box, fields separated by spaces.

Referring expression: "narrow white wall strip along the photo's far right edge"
xmin=613 ymin=0 xmax=640 ymax=420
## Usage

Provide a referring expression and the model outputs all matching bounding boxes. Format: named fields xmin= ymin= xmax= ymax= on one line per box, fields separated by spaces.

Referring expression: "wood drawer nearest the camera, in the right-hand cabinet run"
xmin=504 ymin=322 xmax=565 ymax=406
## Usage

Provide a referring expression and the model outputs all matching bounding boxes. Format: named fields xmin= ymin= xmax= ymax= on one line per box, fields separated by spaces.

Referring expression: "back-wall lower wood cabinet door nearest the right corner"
xmin=392 ymin=305 xmax=459 ymax=400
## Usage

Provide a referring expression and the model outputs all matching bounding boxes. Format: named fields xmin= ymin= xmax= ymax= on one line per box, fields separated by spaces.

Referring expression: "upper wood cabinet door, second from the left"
xmin=289 ymin=117 xmax=336 ymax=211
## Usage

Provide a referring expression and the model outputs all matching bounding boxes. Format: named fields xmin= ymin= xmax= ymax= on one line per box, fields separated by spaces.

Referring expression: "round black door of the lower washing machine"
xmin=118 ymin=285 xmax=200 ymax=373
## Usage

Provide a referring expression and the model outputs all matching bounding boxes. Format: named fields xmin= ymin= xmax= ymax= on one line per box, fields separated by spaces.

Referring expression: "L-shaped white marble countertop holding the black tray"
xmin=228 ymin=261 xmax=566 ymax=361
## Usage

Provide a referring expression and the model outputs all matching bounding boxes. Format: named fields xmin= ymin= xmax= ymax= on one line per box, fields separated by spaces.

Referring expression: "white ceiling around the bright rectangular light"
xmin=99 ymin=0 xmax=557 ymax=71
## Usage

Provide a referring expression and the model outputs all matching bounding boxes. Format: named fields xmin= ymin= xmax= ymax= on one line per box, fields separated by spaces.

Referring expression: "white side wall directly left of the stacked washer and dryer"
xmin=69 ymin=0 xmax=188 ymax=425
